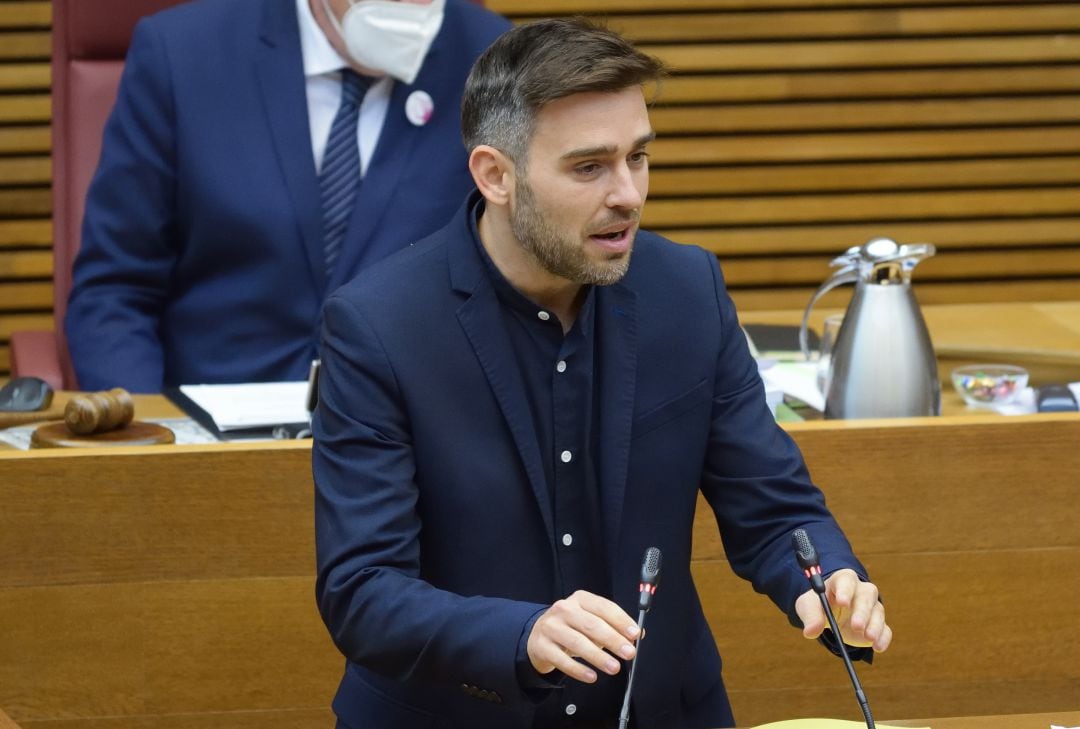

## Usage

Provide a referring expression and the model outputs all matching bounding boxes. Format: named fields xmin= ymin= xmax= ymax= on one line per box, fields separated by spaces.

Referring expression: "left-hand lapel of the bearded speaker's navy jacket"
xmin=447 ymin=217 xmax=555 ymax=557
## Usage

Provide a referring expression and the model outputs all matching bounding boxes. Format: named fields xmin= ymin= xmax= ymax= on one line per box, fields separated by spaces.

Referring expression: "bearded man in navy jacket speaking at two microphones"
xmin=313 ymin=21 xmax=892 ymax=729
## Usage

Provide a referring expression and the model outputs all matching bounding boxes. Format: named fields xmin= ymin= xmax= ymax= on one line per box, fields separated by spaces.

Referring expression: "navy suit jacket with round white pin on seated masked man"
xmin=66 ymin=0 xmax=510 ymax=392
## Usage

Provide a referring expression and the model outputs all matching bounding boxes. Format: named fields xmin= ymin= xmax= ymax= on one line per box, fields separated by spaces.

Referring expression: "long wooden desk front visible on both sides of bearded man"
xmin=0 ymin=415 xmax=1080 ymax=729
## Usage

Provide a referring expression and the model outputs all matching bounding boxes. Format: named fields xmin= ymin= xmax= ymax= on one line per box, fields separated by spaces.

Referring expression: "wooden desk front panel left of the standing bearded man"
xmin=0 ymin=442 xmax=343 ymax=729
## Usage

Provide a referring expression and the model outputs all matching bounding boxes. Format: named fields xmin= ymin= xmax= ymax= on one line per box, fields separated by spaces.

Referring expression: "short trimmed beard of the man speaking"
xmin=510 ymin=178 xmax=637 ymax=286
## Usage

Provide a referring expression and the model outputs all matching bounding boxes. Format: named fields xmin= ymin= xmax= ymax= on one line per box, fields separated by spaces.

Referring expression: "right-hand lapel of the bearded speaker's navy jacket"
xmin=596 ymin=283 xmax=637 ymax=574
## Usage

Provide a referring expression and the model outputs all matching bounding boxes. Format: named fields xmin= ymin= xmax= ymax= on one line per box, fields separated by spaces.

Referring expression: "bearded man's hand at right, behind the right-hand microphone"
xmin=795 ymin=569 xmax=892 ymax=653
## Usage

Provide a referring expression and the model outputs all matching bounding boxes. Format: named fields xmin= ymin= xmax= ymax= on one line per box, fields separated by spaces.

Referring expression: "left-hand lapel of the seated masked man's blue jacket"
xmin=255 ymin=0 xmax=326 ymax=292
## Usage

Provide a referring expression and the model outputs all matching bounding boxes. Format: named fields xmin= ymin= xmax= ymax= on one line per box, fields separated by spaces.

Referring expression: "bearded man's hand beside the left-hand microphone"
xmin=527 ymin=590 xmax=639 ymax=684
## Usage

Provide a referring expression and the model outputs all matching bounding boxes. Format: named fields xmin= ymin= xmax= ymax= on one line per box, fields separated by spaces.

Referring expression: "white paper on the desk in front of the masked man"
xmin=179 ymin=381 xmax=309 ymax=431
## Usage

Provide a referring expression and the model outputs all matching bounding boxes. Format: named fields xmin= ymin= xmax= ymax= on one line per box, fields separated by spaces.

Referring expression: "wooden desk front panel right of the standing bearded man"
xmin=695 ymin=415 xmax=1080 ymax=726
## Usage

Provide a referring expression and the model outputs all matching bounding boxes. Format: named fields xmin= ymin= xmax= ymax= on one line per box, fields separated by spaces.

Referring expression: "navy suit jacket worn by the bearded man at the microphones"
xmin=313 ymin=195 xmax=863 ymax=729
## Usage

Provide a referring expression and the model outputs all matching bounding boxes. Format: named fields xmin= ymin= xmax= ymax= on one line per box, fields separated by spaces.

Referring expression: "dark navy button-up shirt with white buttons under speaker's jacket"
xmin=471 ymin=201 xmax=629 ymax=729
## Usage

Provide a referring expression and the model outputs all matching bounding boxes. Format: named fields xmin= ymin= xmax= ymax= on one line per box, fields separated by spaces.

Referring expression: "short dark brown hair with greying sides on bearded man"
xmin=461 ymin=17 xmax=665 ymax=165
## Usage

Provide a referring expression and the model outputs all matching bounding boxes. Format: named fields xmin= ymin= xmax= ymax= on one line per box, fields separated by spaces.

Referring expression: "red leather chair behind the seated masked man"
xmin=11 ymin=0 xmax=180 ymax=390
